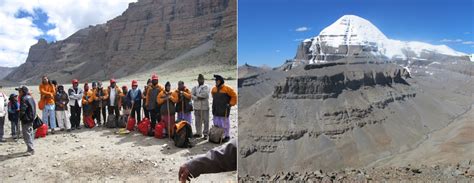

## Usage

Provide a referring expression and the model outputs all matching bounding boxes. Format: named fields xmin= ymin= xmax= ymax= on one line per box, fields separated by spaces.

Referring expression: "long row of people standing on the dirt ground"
xmin=0 ymin=74 xmax=237 ymax=154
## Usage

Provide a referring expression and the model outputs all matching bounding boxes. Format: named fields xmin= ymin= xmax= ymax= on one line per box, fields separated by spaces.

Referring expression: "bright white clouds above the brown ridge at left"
xmin=0 ymin=0 xmax=137 ymax=67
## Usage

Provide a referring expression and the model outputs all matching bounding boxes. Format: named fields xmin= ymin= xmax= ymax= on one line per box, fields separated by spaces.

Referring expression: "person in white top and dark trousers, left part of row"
xmin=68 ymin=79 xmax=84 ymax=130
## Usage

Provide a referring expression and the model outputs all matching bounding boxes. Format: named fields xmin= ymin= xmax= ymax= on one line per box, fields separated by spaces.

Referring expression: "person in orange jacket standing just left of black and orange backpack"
xmin=157 ymin=82 xmax=178 ymax=136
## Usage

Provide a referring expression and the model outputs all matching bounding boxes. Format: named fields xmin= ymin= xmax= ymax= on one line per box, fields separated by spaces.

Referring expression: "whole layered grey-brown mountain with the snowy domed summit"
xmin=238 ymin=16 xmax=474 ymax=180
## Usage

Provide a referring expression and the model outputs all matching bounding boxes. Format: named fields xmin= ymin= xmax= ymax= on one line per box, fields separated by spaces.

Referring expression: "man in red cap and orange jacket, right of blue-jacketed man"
xmin=145 ymin=74 xmax=164 ymax=129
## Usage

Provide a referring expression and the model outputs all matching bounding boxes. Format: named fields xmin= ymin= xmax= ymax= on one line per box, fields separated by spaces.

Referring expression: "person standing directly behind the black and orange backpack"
xmin=174 ymin=81 xmax=193 ymax=126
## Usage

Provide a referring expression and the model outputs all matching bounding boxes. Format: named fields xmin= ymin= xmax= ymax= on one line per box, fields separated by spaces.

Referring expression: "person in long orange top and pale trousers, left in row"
xmin=38 ymin=76 xmax=56 ymax=134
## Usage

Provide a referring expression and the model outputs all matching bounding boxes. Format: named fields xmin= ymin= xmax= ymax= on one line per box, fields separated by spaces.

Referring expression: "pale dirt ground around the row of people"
xmin=0 ymin=70 xmax=237 ymax=182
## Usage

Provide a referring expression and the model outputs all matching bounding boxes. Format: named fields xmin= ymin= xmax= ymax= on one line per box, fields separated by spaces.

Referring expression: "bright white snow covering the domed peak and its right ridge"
xmin=304 ymin=15 xmax=466 ymax=59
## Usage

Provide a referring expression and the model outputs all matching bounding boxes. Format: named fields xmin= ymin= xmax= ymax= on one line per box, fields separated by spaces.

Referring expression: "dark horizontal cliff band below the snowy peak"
xmin=273 ymin=63 xmax=410 ymax=99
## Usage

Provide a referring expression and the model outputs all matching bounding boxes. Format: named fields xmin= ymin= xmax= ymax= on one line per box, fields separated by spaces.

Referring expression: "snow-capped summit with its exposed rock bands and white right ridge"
xmin=296 ymin=15 xmax=468 ymax=63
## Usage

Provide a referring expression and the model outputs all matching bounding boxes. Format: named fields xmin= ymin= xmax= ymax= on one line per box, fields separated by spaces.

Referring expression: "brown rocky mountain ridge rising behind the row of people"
xmin=5 ymin=0 xmax=237 ymax=83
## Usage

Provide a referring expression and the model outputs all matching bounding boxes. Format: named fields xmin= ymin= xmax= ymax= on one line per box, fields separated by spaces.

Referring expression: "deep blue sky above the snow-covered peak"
xmin=238 ymin=0 xmax=474 ymax=66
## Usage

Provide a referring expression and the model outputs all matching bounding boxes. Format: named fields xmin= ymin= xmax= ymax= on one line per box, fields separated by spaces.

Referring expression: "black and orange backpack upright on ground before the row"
xmin=173 ymin=120 xmax=193 ymax=148
